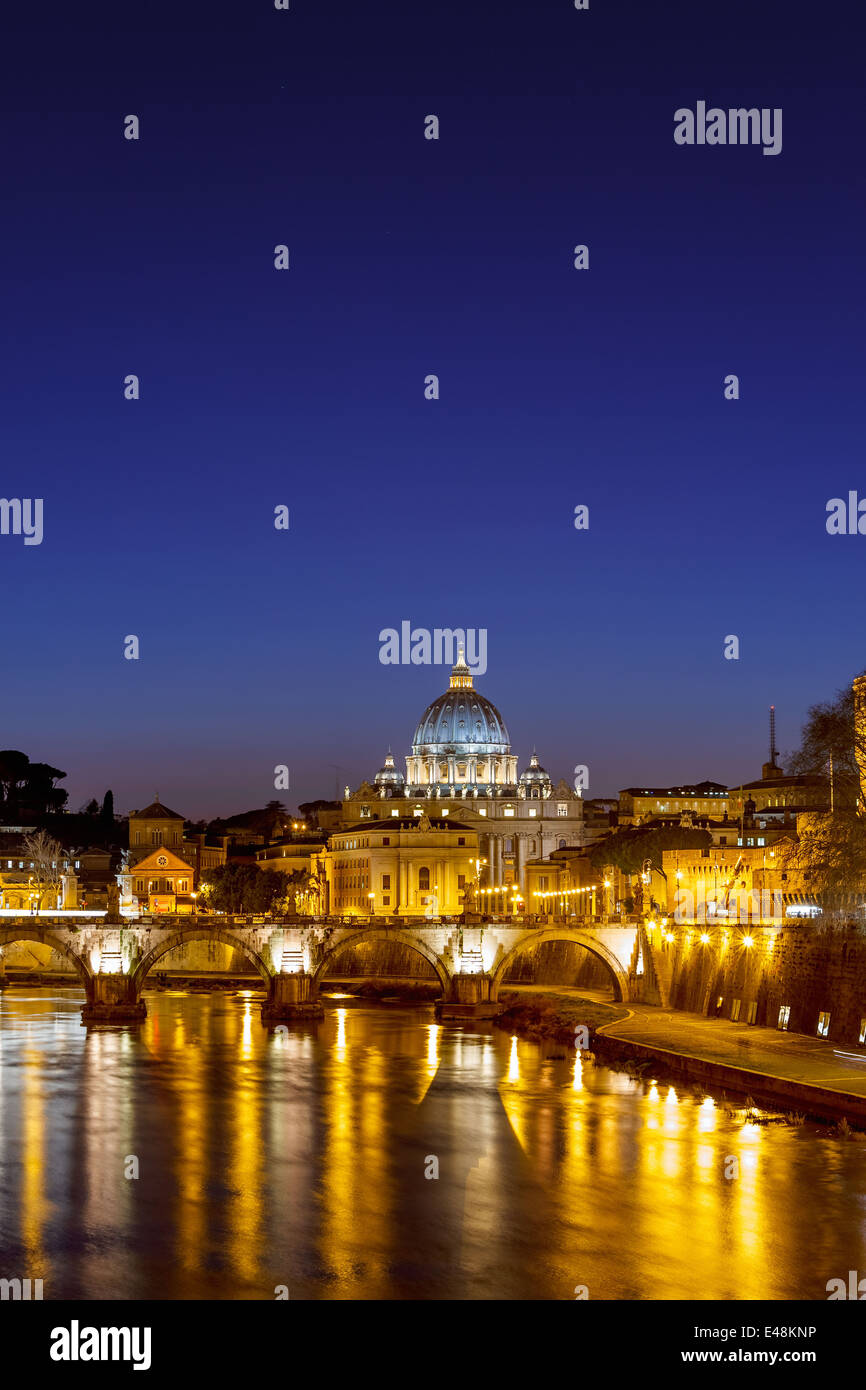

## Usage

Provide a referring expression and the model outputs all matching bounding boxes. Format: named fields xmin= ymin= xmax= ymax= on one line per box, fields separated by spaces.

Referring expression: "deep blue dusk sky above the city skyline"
xmin=0 ymin=0 xmax=866 ymax=816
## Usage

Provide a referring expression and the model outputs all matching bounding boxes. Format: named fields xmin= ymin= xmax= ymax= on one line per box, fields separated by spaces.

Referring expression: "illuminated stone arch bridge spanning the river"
xmin=0 ymin=915 xmax=639 ymax=1023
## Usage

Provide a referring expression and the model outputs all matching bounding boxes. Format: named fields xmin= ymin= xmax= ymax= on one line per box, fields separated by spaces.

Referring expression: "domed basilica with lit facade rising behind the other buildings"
xmin=342 ymin=649 xmax=584 ymax=908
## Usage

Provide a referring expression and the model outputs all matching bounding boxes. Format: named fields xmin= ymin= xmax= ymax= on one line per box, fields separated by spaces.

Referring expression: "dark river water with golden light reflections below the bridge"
xmin=0 ymin=988 xmax=866 ymax=1300
